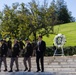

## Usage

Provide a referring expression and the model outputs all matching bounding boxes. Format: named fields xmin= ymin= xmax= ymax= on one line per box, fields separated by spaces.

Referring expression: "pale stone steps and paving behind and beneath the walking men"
xmin=0 ymin=56 xmax=76 ymax=75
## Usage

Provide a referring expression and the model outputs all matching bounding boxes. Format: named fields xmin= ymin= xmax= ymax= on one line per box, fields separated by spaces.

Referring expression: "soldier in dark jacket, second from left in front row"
xmin=9 ymin=39 xmax=20 ymax=72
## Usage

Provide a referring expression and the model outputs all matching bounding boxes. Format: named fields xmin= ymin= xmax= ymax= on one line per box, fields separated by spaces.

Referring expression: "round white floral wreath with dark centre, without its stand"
xmin=54 ymin=34 xmax=66 ymax=48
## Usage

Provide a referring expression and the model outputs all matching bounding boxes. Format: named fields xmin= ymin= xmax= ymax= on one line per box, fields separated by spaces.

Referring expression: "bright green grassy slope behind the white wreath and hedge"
xmin=43 ymin=22 xmax=76 ymax=46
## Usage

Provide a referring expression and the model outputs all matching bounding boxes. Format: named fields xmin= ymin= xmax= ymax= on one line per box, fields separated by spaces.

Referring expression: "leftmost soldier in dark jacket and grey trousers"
xmin=0 ymin=40 xmax=8 ymax=71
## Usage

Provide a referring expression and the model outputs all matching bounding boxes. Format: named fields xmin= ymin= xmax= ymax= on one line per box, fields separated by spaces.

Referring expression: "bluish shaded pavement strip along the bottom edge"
xmin=0 ymin=71 xmax=76 ymax=75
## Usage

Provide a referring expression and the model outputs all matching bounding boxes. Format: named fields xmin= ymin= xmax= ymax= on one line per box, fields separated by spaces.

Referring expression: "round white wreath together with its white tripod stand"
xmin=53 ymin=34 xmax=66 ymax=56
